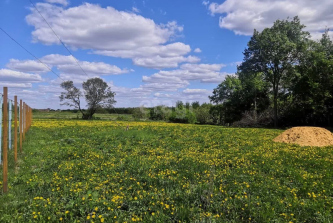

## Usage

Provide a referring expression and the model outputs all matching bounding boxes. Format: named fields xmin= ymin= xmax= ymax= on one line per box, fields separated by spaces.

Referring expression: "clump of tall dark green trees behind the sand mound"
xmin=210 ymin=17 xmax=333 ymax=126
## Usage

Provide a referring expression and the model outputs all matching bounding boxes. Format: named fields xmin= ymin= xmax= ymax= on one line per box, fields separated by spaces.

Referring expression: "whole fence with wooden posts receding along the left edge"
xmin=0 ymin=87 xmax=32 ymax=194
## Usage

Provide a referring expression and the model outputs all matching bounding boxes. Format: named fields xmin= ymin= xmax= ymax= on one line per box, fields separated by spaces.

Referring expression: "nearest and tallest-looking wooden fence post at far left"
xmin=2 ymin=87 xmax=8 ymax=193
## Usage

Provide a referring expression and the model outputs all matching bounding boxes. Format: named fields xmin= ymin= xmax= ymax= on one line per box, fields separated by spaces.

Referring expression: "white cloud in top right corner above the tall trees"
xmin=209 ymin=0 xmax=333 ymax=38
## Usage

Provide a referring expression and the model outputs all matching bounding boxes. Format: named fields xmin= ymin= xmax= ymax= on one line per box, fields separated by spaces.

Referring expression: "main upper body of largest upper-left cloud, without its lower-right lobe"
xmin=26 ymin=3 xmax=182 ymax=50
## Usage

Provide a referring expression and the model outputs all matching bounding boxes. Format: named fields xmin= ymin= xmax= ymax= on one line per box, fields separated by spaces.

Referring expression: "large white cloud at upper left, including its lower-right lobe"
xmin=26 ymin=3 xmax=199 ymax=69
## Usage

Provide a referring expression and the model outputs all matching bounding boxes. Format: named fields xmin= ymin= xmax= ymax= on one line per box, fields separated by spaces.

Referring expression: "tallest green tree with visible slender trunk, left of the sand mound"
xmin=239 ymin=16 xmax=309 ymax=127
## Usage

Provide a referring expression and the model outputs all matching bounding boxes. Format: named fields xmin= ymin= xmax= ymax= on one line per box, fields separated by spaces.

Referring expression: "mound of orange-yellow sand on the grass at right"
xmin=273 ymin=127 xmax=333 ymax=146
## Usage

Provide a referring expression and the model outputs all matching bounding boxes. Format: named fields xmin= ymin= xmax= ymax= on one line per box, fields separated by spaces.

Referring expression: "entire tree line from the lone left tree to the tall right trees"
xmin=60 ymin=16 xmax=333 ymax=127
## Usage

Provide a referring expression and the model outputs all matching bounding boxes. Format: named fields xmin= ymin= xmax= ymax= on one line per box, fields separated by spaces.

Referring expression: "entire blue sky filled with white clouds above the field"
xmin=0 ymin=0 xmax=333 ymax=108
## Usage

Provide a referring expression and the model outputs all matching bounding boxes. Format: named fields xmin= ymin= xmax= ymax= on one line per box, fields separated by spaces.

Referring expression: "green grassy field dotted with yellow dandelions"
xmin=0 ymin=119 xmax=333 ymax=222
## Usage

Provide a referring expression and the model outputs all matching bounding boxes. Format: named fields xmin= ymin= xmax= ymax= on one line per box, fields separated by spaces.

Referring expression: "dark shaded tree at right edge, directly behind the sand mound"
xmin=288 ymin=31 xmax=333 ymax=126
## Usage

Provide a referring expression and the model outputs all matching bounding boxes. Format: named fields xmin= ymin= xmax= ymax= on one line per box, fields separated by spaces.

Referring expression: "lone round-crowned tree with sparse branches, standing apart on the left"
xmin=60 ymin=78 xmax=116 ymax=119
